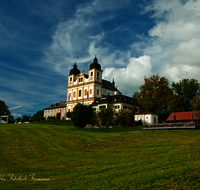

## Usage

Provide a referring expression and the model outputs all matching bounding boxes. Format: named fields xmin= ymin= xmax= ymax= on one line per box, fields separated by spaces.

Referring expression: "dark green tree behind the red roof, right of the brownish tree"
xmin=172 ymin=79 xmax=200 ymax=111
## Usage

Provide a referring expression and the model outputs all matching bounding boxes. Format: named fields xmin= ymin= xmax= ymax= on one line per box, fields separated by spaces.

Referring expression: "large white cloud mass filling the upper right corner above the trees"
xmin=138 ymin=0 xmax=200 ymax=82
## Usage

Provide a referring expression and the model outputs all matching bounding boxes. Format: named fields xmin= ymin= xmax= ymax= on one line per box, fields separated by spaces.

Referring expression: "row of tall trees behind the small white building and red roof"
xmin=133 ymin=75 xmax=200 ymax=117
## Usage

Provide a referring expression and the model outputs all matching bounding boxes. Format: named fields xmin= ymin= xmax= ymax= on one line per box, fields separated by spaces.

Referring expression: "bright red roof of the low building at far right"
xmin=167 ymin=111 xmax=200 ymax=121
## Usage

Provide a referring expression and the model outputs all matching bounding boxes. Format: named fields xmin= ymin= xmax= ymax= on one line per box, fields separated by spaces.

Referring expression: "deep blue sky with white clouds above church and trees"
xmin=0 ymin=0 xmax=200 ymax=118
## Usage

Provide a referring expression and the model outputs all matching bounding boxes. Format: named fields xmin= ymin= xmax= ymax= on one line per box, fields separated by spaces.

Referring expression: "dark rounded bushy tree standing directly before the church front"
xmin=71 ymin=104 xmax=93 ymax=128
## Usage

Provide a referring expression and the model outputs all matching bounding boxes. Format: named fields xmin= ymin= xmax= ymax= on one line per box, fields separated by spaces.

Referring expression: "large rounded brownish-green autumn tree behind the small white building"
xmin=137 ymin=75 xmax=172 ymax=112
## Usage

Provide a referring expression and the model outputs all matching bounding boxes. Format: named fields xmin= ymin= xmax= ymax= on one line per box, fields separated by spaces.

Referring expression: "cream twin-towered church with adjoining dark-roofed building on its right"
xmin=66 ymin=53 xmax=140 ymax=112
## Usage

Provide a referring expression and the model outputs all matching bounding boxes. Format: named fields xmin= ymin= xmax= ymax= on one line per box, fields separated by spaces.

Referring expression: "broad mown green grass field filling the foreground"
xmin=0 ymin=122 xmax=200 ymax=190
